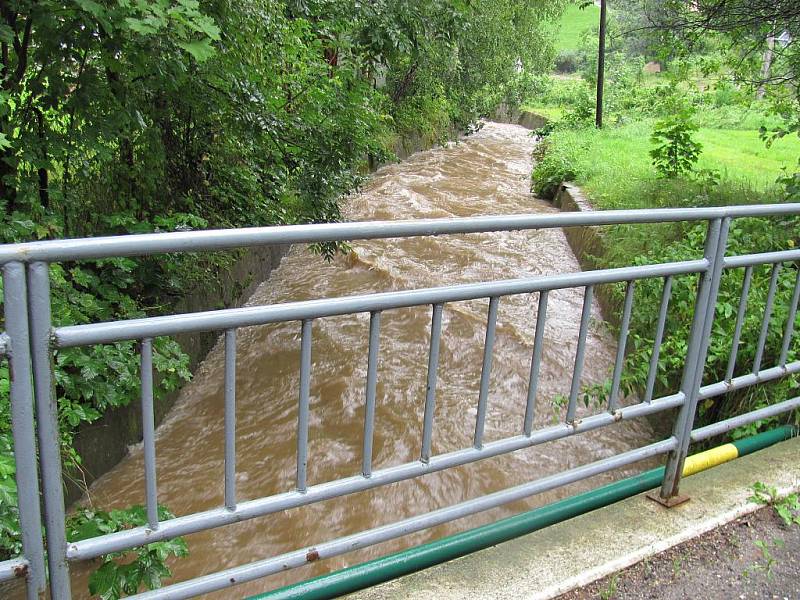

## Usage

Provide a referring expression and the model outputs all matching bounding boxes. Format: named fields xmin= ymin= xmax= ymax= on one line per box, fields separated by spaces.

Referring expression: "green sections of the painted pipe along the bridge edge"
xmin=249 ymin=426 xmax=796 ymax=600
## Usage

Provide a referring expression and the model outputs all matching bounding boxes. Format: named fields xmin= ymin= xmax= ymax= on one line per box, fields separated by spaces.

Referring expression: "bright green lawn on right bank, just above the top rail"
xmin=540 ymin=121 xmax=800 ymax=209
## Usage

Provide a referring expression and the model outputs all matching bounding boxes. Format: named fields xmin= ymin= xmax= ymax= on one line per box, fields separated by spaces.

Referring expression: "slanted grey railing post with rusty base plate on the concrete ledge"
xmin=650 ymin=217 xmax=730 ymax=506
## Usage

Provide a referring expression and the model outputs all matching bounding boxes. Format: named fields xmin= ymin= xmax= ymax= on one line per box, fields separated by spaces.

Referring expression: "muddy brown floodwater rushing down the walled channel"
xmin=67 ymin=123 xmax=653 ymax=598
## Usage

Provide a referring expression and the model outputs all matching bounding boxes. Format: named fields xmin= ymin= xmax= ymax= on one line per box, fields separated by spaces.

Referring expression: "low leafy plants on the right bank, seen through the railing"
xmin=606 ymin=218 xmax=800 ymax=438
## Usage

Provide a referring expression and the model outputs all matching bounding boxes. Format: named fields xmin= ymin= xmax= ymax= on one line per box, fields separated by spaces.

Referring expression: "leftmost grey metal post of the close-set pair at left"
xmin=0 ymin=263 xmax=47 ymax=600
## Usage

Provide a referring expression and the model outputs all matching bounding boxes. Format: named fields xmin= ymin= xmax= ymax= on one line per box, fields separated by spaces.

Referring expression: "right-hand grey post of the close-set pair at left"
xmin=28 ymin=262 xmax=71 ymax=600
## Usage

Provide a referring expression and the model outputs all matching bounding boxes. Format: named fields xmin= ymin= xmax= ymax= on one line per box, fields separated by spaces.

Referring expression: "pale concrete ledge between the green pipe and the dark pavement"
xmin=348 ymin=438 xmax=800 ymax=600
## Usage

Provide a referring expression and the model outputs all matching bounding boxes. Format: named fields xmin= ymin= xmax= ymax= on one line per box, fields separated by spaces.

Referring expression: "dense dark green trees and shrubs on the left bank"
xmin=0 ymin=0 xmax=560 ymax=596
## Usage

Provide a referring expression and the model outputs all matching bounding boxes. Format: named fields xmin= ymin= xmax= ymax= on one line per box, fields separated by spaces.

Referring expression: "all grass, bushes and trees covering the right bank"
xmin=529 ymin=0 xmax=800 ymax=435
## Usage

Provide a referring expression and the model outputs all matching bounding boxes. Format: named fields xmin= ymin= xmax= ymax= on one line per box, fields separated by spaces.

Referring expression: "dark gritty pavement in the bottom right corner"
xmin=558 ymin=507 xmax=800 ymax=600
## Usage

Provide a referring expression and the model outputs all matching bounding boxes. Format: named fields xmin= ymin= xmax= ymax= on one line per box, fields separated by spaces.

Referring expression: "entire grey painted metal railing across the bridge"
xmin=0 ymin=204 xmax=800 ymax=600
